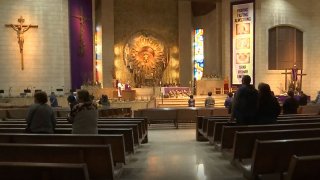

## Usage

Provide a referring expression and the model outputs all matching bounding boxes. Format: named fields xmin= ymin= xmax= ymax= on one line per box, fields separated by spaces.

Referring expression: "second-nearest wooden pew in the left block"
xmin=0 ymin=143 xmax=115 ymax=180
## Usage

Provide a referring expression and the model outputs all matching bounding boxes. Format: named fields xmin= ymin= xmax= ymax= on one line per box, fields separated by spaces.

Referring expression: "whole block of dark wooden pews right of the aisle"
xmin=196 ymin=114 xmax=320 ymax=180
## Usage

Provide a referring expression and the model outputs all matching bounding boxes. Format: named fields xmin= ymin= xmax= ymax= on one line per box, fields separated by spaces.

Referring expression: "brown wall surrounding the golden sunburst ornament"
xmin=114 ymin=0 xmax=179 ymax=82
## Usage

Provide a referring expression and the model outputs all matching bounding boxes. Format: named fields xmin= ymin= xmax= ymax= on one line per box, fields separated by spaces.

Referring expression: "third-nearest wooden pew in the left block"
xmin=0 ymin=133 xmax=126 ymax=166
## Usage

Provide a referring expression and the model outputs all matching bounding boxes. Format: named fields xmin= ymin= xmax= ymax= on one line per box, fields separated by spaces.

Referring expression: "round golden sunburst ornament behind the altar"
xmin=124 ymin=32 xmax=169 ymax=86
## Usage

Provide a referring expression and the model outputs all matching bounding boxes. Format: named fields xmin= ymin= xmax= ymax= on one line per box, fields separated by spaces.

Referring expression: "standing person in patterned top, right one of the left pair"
xmin=68 ymin=90 xmax=98 ymax=134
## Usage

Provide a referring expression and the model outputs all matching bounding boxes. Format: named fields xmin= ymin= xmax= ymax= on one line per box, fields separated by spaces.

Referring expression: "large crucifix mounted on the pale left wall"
xmin=5 ymin=16 xmax=38 ymax=70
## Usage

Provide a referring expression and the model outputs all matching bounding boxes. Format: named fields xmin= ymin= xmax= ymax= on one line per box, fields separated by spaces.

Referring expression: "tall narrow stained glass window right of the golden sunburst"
xmin=194 ymin=29 xmax=204 ymax=80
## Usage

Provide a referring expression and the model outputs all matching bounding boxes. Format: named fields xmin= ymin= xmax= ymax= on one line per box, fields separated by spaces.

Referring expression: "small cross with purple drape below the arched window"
xmin=281 ymin=65 xmax=307 ymax=92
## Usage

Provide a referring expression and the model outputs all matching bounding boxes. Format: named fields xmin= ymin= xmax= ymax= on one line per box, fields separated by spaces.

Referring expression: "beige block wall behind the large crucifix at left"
xmin=0 ymin=0 xmax=71 ymax=95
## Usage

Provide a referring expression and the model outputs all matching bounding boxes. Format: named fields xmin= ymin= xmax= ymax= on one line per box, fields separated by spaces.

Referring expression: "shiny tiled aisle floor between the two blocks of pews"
xmin=120 ymin=129 xmax=244 ymax=180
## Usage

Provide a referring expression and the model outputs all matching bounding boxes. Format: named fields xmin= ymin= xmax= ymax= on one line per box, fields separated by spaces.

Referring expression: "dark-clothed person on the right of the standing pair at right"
xmin=257 ymin=83 xmax=281 ymax=124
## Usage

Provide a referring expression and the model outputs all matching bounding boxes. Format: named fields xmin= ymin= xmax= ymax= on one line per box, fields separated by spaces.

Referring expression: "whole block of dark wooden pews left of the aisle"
xmin=0 ymin=117 xmax=148 ymax=180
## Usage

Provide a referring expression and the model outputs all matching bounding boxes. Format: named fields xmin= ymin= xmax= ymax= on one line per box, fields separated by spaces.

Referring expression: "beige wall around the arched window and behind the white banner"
xmin=222 ymin=0 xmax=320 ymax=98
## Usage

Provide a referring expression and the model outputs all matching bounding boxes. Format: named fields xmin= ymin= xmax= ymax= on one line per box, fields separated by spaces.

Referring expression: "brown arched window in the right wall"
xmin=269 ymin=26 xmax=303 ymax=70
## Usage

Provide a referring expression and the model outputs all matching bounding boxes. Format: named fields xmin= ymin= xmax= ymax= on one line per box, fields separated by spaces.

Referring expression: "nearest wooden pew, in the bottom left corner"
xmin=0 ymin=162 xmax=89 ymax=180
